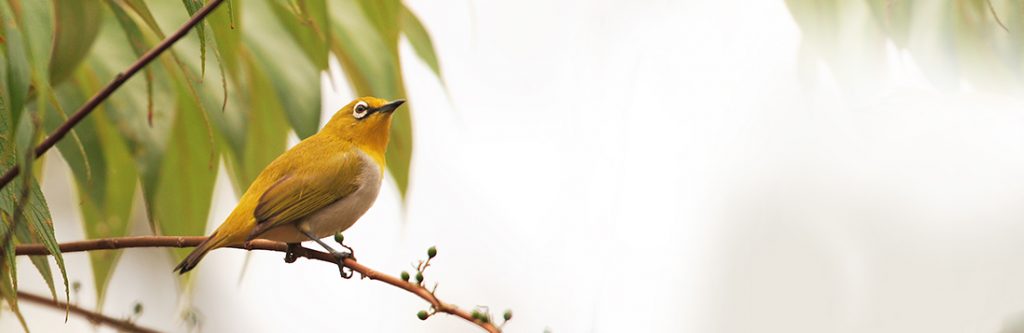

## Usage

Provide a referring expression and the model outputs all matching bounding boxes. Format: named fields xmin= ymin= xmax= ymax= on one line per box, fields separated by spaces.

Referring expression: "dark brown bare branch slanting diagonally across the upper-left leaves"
xmin=0 ymin=0 xmax=224 ymax=189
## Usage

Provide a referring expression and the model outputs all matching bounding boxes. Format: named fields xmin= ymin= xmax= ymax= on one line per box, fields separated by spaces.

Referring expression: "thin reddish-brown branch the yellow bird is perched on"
xmin=14 ymin=236 xmax=501 ymax=333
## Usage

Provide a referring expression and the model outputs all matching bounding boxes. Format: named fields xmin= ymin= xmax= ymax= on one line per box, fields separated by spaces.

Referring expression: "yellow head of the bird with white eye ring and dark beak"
xmin=322 ymin=96 xmax=406 ymax=152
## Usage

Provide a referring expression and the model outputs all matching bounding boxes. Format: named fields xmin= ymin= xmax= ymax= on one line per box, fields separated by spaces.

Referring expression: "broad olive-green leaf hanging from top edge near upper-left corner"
xmin=50 ymin=0 xmax=103 ymax=86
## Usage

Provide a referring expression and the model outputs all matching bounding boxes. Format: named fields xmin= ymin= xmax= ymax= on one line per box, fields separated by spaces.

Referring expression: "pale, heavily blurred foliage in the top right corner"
xmin=785 ymin=0 xmax=1024 ymax=92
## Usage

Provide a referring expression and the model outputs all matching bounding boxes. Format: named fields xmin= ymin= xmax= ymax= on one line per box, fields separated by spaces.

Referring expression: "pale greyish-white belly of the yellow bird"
xmin=258 ymin=154 xmax=381 ymax=243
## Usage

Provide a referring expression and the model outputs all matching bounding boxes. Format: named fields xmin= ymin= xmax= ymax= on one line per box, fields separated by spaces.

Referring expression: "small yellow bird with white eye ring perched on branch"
xmin=174 ymin=96 xmax=404 ymax=278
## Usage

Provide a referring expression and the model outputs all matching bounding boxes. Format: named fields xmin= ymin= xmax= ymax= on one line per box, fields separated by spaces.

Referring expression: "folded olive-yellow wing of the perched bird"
xmin=249 ymin=147 xmax=366 ymax=240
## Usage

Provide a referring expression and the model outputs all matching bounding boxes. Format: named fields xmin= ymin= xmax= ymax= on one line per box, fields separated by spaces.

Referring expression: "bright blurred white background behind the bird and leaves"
xmin=9 ymin=0 xmax=1024 ymax=332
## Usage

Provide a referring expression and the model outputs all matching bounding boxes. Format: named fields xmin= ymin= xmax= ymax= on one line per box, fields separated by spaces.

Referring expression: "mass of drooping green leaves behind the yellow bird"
xmin=0 ymin=0 xmax=440 ymax=323
